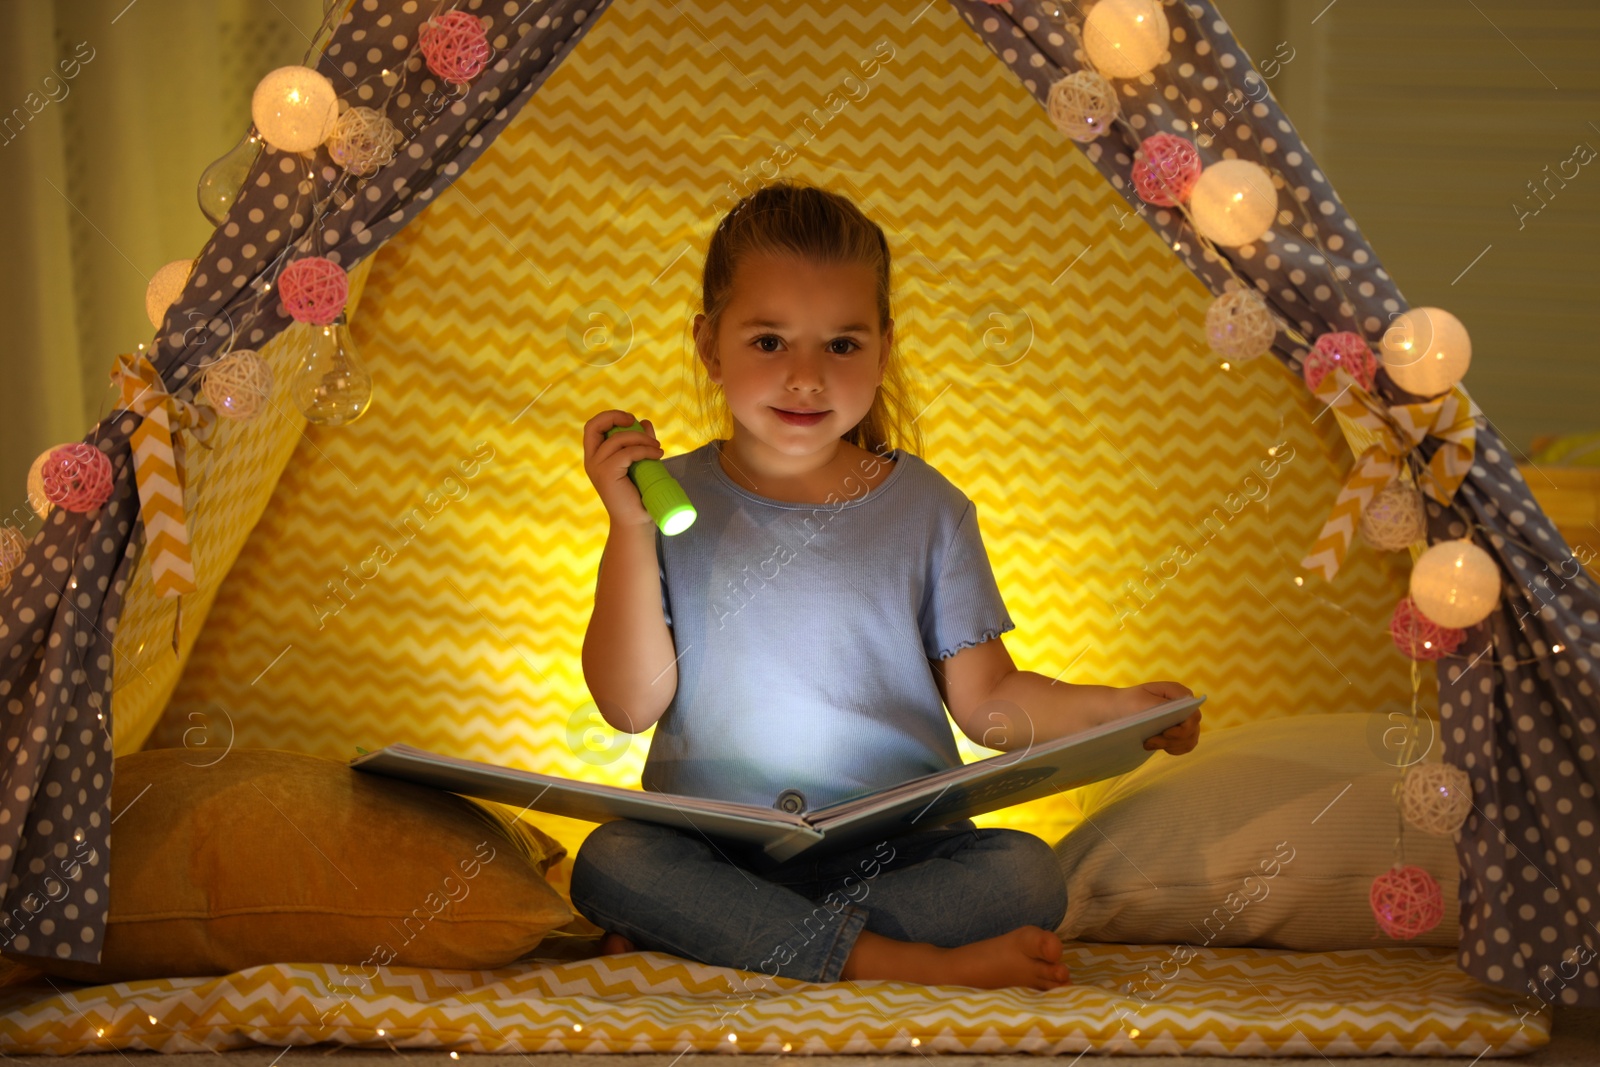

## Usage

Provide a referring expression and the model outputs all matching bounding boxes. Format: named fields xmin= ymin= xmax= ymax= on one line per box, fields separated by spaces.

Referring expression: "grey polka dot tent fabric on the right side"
xmin=952 ymin=0 xmax=1600 ymax=1006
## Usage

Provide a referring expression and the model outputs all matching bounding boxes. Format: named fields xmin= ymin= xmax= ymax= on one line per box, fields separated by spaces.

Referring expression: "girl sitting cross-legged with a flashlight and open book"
xmin=571 ymin=181 xmax=1198 ymax=989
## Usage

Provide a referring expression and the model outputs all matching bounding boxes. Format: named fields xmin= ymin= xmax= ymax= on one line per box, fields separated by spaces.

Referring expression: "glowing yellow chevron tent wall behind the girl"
xmin=117 ymin=0 xmax=1434 ymax=875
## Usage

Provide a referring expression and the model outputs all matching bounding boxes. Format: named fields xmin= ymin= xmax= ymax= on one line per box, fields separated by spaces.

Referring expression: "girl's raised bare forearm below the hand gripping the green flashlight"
xmin=584 ymin=522 xmax=678 ymax=734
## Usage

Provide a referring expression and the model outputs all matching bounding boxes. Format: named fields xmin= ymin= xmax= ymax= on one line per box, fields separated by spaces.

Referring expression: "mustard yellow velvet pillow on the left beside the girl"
xmin=5 ymin=749 xmax=573 ymax=984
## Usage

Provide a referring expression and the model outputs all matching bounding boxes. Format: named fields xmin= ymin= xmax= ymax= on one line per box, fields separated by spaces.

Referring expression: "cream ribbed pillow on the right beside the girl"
xmin=1054 ymin=712 xmax=1461 ymax=952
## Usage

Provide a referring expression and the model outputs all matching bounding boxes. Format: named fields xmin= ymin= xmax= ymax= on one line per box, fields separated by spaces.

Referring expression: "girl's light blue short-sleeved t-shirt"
xmin=640 ymin=442 xmax=1016 ymax=811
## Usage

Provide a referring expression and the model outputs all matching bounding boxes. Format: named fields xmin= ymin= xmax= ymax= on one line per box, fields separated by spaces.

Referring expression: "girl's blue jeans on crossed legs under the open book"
xmin=571 ymin=819 xmax=1067 ymax=982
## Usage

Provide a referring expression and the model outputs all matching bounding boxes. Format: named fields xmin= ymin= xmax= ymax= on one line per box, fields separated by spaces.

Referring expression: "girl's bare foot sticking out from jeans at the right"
xmin=840 ymin=926 xmax=1070 ymax=989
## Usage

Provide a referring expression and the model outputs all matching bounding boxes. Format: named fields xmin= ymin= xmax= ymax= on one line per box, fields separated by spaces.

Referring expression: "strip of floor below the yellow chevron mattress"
xmin=3 ymin=1008 xmax=1600 ymax=1067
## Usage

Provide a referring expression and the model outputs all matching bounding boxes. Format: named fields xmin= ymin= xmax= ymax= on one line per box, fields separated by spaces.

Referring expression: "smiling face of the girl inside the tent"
xmin=694 ymin=254 xmax=894 ymax=466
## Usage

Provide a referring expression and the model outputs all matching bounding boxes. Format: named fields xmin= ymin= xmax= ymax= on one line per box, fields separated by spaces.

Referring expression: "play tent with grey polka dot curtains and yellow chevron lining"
xmin=0 ymin=0 xmax=1600 ymax=1051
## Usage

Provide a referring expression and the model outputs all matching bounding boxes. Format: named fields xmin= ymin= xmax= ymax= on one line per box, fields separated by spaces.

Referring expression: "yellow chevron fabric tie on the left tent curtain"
xmin=110 ymin=352 xmax=216 ymax=651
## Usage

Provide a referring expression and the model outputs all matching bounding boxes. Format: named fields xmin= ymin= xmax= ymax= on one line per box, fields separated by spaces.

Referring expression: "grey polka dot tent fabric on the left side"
xmin=0 ymin=0 xmax=605 ymax=963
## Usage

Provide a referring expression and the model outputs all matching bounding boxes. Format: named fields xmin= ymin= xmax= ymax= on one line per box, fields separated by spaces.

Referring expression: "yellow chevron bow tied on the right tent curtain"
xmin=1301 ymin=368 xmax=1482 ymax=581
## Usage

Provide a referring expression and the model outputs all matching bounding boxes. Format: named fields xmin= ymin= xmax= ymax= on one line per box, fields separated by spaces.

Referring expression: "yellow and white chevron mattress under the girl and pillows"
xmin=0 ymin=941 xmax=1552 ymax=1057
